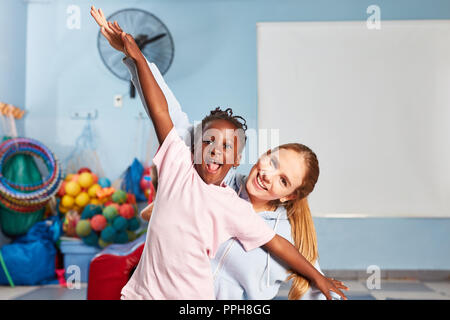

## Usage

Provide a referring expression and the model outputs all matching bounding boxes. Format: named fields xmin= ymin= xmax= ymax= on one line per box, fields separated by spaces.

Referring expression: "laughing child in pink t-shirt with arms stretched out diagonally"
xmin=91 ymin=8 xmax=345 ymax=299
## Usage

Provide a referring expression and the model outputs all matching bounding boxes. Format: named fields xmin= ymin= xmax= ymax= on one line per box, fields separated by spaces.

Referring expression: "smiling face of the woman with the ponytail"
xmin=246 ymin=149 xmax=307 ymax=202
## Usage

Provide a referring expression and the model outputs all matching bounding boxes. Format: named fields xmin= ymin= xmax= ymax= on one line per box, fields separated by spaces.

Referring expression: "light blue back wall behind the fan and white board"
xmin=17 ymin=0 xmax=450 ymax=269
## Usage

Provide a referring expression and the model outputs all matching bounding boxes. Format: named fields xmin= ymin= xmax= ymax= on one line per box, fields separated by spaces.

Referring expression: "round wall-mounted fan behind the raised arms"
xmin=97 ymin=9 xmax=174 ymax=98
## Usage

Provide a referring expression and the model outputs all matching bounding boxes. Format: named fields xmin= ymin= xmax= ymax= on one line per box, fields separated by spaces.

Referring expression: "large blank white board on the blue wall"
xmin=257 ymin=20 xmax=450 ymax=217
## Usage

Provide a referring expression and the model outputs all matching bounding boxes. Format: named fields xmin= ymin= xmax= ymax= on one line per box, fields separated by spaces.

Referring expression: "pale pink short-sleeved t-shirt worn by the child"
xmin=122 ymin=128 xmax=275 ymax=300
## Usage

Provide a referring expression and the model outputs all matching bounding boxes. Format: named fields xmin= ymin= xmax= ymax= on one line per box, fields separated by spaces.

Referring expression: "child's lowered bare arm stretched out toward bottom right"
xmin=263 ymin=235 xmax=347 ymax=300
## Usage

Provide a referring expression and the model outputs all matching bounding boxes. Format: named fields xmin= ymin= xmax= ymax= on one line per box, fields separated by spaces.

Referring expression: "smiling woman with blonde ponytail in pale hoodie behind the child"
xmin=91 ymin=10 xmax=346 ymax=299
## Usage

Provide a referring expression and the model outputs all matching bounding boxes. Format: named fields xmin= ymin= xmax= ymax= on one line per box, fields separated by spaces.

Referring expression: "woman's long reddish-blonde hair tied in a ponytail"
xmin=271 ymin=143 xmax=319 ymax=300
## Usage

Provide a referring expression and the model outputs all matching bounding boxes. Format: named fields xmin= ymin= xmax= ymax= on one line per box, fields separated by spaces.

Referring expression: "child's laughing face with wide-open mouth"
xmin=194 ymin=120 xmax=241 ymax=185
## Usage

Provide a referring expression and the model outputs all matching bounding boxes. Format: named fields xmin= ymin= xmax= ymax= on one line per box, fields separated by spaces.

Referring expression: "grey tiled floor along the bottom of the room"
xmin=0 ymin=280 xmax=450 ymax=300
